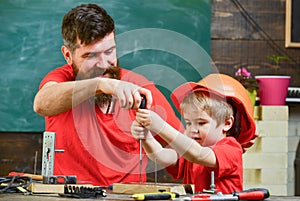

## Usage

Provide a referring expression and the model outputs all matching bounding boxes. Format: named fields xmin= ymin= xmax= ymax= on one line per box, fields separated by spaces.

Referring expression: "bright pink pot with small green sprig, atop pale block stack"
xmin=255 ymin=55 xmax=291 ymax=105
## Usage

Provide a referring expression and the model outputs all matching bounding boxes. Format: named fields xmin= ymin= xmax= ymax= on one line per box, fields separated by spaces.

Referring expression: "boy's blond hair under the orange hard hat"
xmin=180 ymin=92 xmax=234 ymax=125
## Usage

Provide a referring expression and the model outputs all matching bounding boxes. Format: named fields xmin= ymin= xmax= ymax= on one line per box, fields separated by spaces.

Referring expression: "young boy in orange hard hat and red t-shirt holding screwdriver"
xmin=131 ymin=74 xmax=256 ymax=193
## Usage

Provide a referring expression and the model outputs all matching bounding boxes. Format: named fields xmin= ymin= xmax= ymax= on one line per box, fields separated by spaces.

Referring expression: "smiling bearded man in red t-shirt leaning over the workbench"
xmin=34 ymin=4 xmax=182 ymax=186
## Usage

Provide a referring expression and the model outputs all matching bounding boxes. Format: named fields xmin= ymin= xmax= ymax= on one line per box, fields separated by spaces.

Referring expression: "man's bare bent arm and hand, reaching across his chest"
xmin=33 ymin=78 xmax=152 ymax=116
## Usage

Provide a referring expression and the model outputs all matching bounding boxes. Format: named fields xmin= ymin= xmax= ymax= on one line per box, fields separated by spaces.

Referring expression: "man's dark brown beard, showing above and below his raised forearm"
xmin=73 ymin=64 xmax=121 ymax=107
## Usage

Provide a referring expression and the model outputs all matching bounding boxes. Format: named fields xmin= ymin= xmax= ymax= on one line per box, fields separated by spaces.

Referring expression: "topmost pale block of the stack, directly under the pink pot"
xmin=254 ymin=105 xmax=289 ymax=121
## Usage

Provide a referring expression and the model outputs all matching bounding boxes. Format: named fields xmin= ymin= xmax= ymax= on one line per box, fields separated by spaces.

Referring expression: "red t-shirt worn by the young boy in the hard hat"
xmin=166 ymin=137 xmax=243 ymax=194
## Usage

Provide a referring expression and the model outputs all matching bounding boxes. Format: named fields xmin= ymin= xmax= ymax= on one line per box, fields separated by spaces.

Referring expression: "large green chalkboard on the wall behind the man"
xmin=0 ymin=0 xmax=211 ymax=132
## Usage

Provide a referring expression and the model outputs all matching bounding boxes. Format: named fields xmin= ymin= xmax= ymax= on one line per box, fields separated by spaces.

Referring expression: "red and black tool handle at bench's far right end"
xmin=237 ymin=188 xmax=270 ymax=200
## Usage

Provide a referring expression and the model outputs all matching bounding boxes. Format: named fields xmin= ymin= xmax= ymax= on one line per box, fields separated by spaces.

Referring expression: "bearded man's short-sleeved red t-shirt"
xmin=40 ymin=64 xmax=183 ymax=186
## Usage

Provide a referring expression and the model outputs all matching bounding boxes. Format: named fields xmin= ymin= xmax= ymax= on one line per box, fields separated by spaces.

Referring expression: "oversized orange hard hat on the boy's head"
xmin=171 ymin=74 xmax=257 ymax=148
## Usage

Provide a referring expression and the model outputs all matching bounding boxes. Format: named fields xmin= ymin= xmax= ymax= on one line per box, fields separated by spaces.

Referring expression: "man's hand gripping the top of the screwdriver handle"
xmin=97 ymin=78 xmax=152 ymax=109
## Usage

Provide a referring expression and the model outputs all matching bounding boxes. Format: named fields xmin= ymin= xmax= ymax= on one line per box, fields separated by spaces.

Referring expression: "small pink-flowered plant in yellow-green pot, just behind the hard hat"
xmin=235 ymin=67 xmax=259 ymax=107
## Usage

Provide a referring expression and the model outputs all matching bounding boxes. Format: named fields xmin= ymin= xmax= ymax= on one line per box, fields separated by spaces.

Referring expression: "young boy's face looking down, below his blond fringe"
xmin=183 ymin=106 xmax=226 ymax=147
